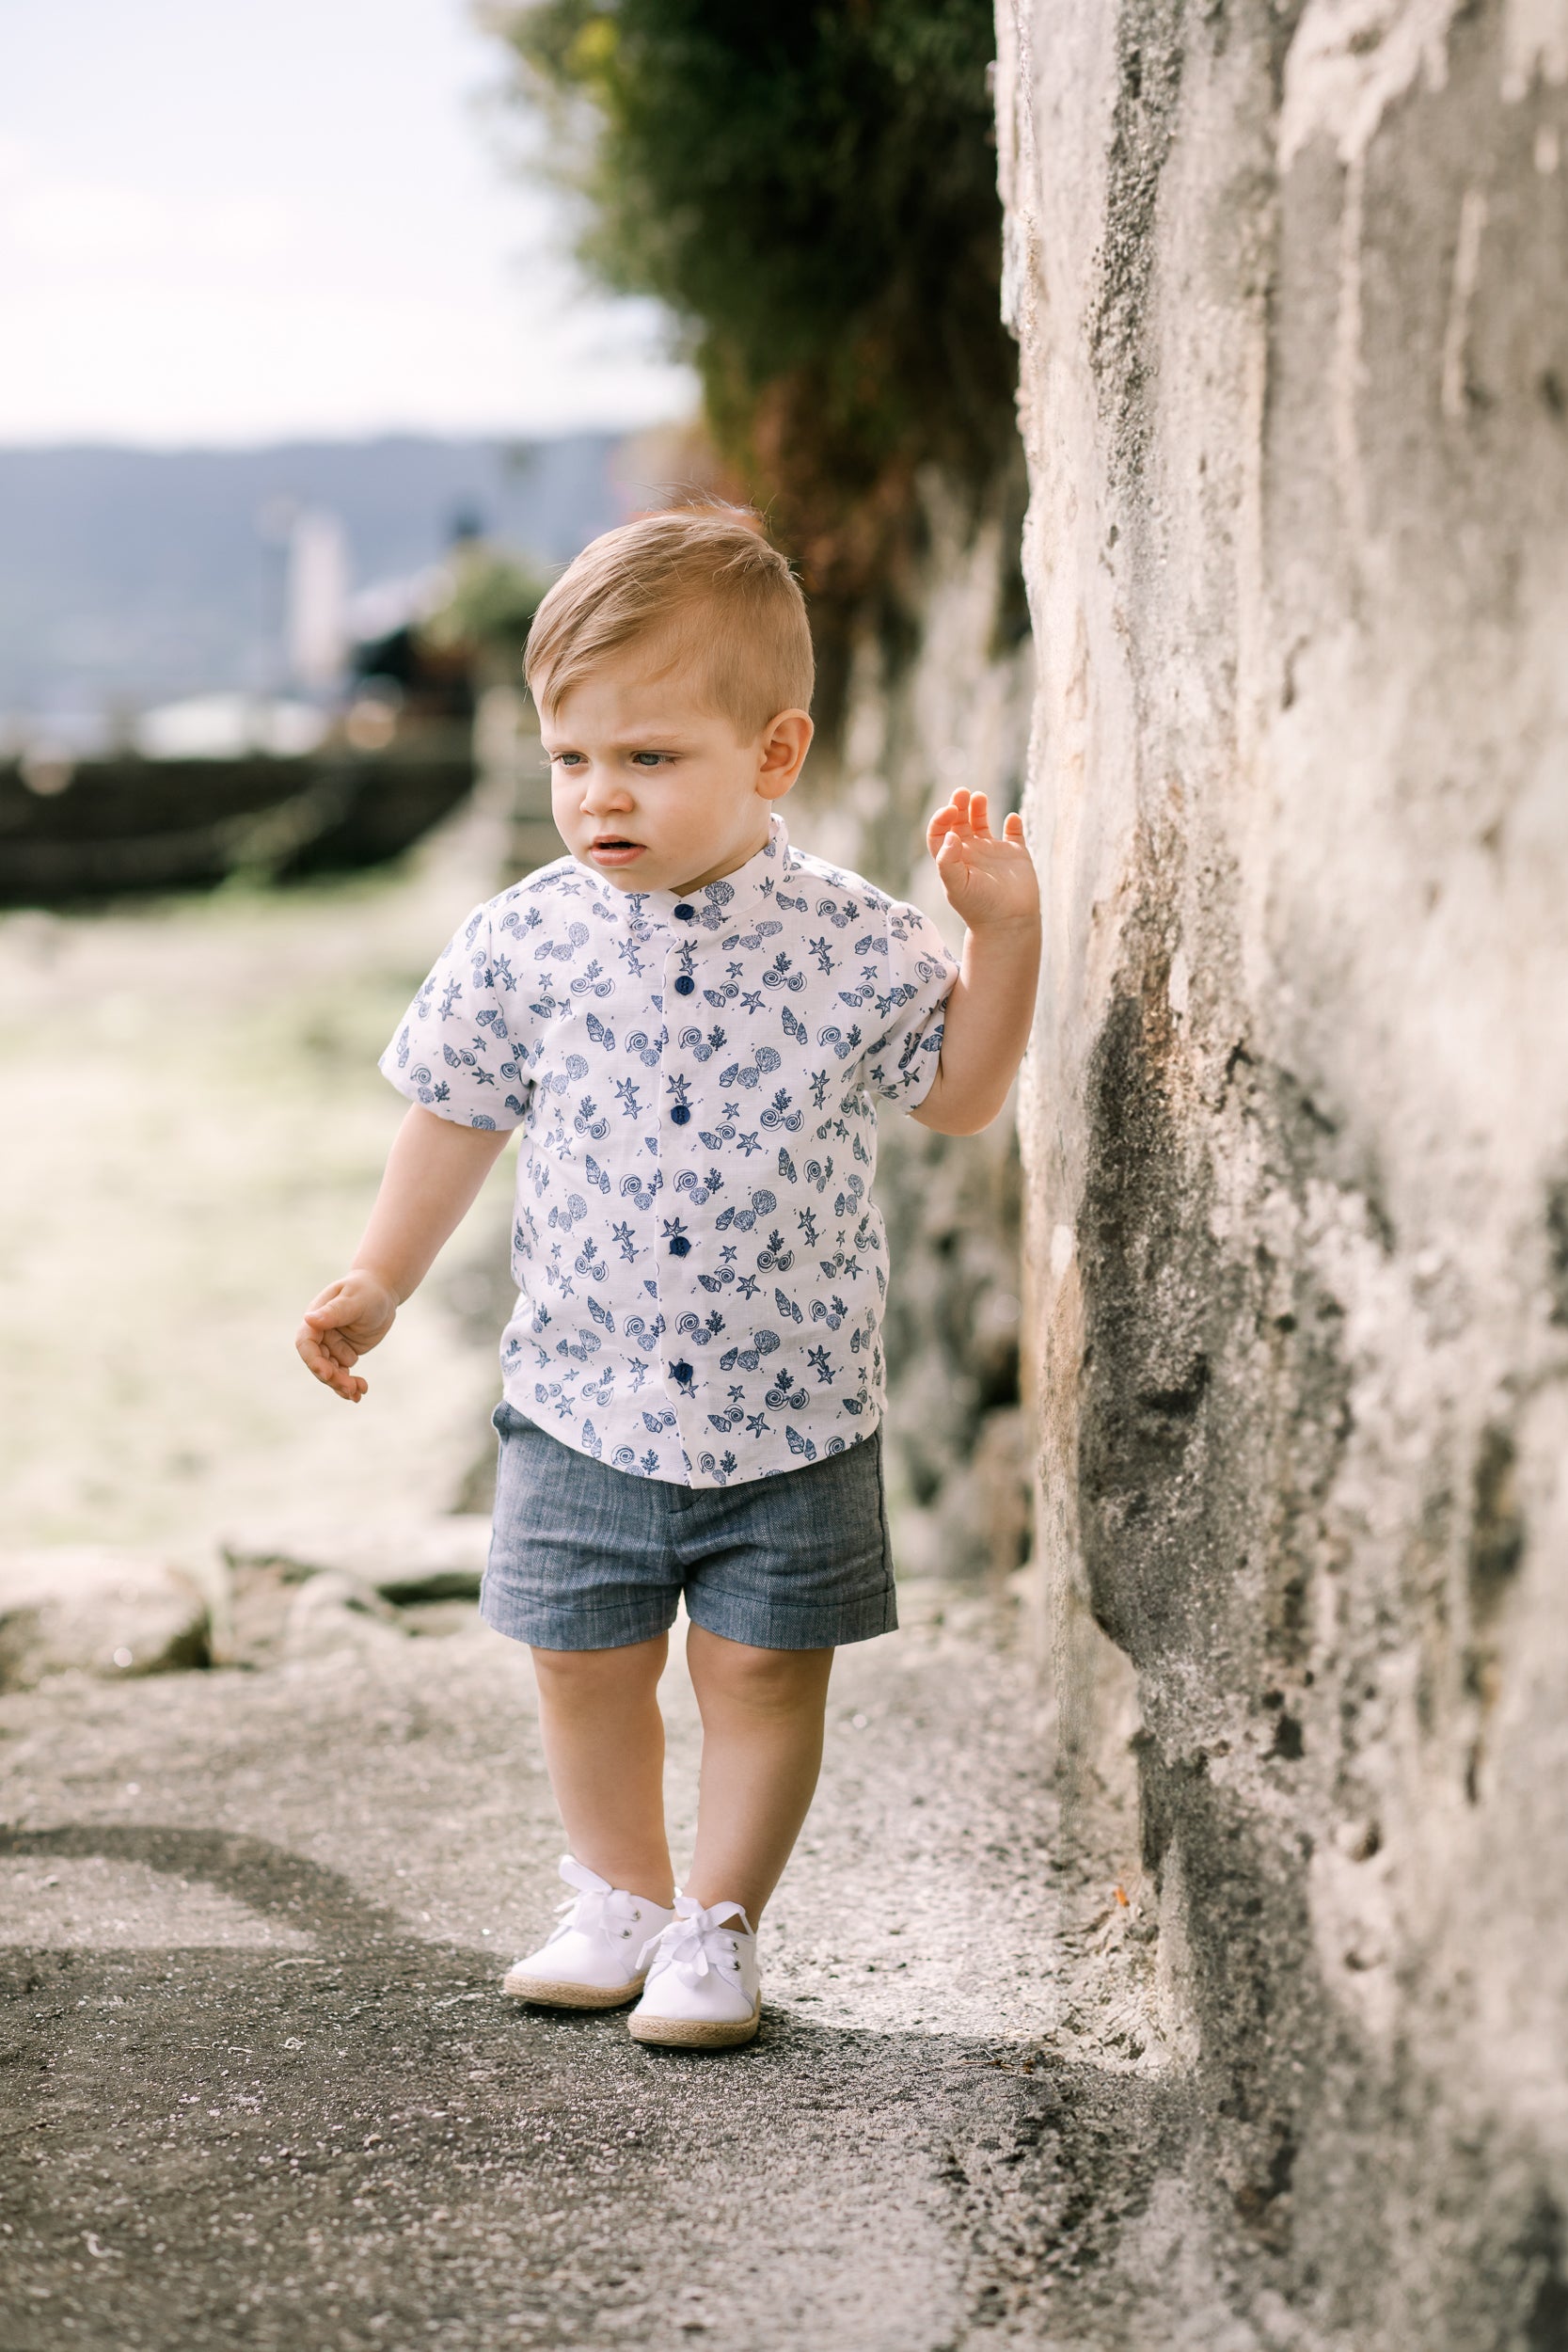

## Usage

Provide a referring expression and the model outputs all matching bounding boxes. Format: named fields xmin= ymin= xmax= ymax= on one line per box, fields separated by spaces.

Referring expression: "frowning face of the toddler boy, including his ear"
xmin=541 ymin=644 xmax=811 ymax=892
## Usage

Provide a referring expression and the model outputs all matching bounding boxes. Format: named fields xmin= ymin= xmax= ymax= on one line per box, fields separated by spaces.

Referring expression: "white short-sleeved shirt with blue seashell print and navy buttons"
xmin=381 ymin=814 xmax=957 ymax=1486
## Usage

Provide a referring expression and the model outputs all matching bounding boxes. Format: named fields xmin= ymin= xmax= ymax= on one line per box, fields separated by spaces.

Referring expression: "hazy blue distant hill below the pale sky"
xmin=0 ymin=433 xmax=626 ymax=718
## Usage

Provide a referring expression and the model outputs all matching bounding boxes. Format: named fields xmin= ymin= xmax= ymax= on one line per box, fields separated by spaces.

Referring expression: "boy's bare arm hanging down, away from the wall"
xmin=293 ymin=1104 xmax=510 ymax=1405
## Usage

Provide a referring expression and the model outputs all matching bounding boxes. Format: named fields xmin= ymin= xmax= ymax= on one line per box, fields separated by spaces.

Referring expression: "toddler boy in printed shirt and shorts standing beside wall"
xmin=298 ymin=508 xmax=1039 ymax=2049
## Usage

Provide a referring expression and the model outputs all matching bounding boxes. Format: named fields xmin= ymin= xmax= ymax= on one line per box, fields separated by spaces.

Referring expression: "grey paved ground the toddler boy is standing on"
xmin=0 ymin=1593 xmax=1212 ymax=2352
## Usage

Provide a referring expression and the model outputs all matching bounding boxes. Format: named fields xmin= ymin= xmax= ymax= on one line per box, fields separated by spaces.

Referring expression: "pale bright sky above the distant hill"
xmin=0 ymin=0 xmax=693 ymax=447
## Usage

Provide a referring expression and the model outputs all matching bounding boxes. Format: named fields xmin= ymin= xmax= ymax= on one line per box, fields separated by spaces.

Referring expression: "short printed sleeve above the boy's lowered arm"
xmin=381 ymin=906 xmax=533 ymax=1127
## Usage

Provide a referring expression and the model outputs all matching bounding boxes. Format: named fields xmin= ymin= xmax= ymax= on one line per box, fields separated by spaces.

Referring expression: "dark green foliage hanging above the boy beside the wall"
xmin=499 ymin=0 xmax=1016 ymax=596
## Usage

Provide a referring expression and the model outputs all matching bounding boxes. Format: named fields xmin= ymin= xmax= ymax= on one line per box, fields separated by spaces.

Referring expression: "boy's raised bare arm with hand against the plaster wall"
xmin=910 ymin=793 xmax=1039 ymax=1136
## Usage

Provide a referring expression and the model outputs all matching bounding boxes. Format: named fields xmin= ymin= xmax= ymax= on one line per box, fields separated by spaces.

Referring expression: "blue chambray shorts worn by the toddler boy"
xmin=480 ymin=1405 xmax=898 ymax=1649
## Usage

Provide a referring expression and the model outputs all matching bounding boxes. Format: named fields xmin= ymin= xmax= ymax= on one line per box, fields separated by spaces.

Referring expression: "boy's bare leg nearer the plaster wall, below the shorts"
xmin=687 ymin=1626 xmax=832 ymax=1927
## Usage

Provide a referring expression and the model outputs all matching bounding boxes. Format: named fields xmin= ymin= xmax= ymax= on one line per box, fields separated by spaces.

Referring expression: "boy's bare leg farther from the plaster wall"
xmin=533 ymin=1632 xmax=674 ymax=1910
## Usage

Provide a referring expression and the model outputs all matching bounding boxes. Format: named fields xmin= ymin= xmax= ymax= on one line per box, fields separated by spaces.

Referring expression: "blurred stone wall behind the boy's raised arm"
xmin=785 ymin=464 xmax=1035 ymax=1585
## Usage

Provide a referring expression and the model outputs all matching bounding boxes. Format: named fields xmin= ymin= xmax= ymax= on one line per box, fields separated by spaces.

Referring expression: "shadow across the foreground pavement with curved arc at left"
xmin=0 ymin=1825 xmax=1173 ymax=2352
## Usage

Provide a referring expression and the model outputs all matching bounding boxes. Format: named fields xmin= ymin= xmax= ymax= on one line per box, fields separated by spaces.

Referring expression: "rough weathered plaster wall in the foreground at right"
xmin=999 ymin=0 xmax=1568 ymax=2352
